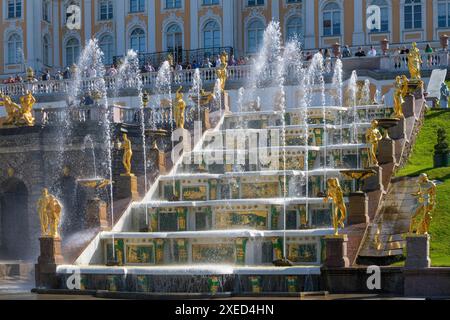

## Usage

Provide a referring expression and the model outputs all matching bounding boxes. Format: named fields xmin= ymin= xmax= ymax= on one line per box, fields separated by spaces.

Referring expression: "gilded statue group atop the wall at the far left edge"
xmin=0 ymin=90 xmax=36 ymax=126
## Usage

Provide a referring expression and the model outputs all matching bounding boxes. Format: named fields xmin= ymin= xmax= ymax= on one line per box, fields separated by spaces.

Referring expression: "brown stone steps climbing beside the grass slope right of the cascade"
xmin=355 ymin=96 xmax=425 ymax=265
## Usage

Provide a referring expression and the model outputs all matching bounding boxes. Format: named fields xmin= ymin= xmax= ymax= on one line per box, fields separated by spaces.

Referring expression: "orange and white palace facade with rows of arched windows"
xmin=0 ymin=0 xmax=450 ymax=75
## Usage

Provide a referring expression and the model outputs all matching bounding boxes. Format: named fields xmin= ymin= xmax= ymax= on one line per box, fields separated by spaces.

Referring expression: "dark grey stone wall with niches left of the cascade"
xmin=0 ymin=123 xmax=166 ymax=260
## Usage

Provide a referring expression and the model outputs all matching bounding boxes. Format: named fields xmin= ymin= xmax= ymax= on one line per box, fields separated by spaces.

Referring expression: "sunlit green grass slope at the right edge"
xmin=397 ymin=109 xmax=450 ymax=267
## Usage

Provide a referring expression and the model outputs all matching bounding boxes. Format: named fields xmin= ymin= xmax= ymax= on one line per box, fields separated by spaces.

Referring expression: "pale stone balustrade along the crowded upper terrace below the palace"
xmin=0 ymin=51 xmax=449 ymax=96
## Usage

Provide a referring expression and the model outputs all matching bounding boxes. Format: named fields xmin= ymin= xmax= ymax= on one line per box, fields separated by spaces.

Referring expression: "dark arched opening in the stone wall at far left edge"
xmin=0 ymin=178 xmax=31 ymax=259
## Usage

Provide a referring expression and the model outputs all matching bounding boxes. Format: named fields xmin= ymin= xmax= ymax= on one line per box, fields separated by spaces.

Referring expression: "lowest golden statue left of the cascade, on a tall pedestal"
xmin=37 ymin=188 xmax=62 ymax=238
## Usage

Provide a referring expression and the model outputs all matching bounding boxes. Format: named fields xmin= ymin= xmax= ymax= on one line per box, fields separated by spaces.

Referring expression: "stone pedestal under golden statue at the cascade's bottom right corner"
xmin=324 ymin=234 xmax=350 ymax=268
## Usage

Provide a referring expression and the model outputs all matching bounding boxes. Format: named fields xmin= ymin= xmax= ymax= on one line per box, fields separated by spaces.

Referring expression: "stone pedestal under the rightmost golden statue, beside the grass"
xmin=405 ymin=235 xmax=431 ymax=269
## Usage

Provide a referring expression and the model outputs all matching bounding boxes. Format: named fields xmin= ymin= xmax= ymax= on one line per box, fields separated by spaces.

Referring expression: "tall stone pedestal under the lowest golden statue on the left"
xmin=35 ymin=237 xmax=64 ymax=289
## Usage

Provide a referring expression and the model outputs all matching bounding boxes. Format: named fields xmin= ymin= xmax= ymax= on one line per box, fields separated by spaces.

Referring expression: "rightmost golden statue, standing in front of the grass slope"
xmin=409 ymin=173 xmax=436 ymax=234
